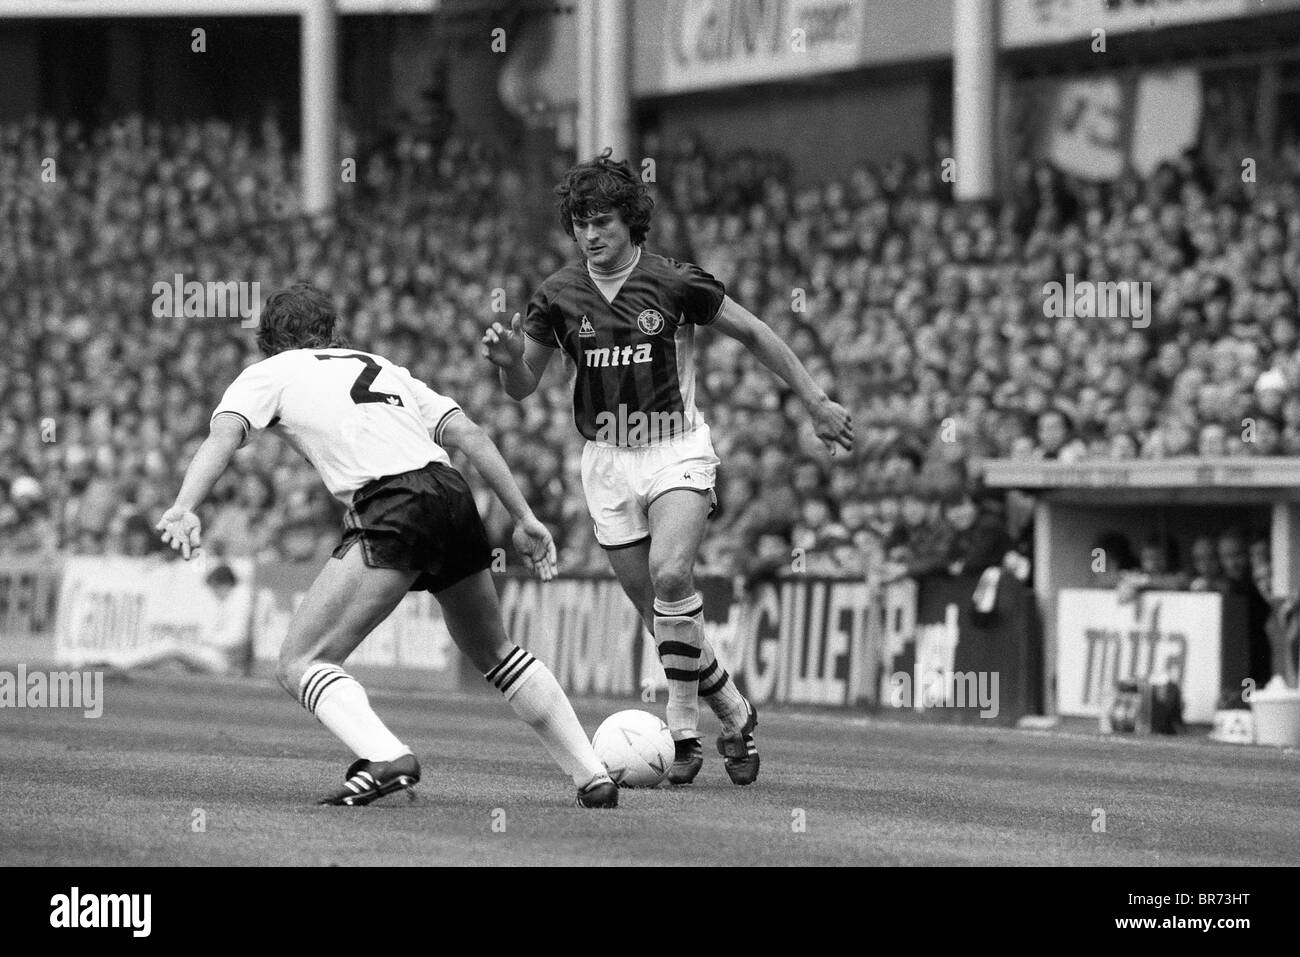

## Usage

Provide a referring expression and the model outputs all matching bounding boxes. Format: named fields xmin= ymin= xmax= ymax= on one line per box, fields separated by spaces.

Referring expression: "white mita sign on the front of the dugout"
xmin=1056 ymin=588 xmax=1223 ymax=724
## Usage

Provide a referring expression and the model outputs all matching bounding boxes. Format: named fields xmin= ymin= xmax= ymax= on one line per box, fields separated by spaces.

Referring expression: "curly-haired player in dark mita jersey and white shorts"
xmin=482 ymin=150 xmax=853 ymax=784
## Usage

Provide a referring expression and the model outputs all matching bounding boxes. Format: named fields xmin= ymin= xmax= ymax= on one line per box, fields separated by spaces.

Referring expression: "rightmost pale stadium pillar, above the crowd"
xmin=953 ymin=0 xmax=997 ymax=200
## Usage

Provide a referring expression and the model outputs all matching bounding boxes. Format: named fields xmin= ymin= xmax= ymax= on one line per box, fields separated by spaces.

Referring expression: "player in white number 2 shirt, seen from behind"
xmin=157 ymin=283 xmax=618 ymax=807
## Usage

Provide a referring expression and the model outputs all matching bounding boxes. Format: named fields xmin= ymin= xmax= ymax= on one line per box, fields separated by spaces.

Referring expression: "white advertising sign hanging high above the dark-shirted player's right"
xmin=662 ymin=0 xmax=868 ymax=92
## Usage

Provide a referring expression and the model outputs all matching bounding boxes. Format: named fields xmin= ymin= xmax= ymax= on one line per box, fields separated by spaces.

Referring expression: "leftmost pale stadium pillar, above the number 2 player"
xmin=300 ymin=0 xmax=338 ymax=216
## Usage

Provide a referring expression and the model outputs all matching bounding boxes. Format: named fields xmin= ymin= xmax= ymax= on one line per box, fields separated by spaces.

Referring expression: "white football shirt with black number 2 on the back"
xmin=212 ymin=348 xmax=460 ymax=506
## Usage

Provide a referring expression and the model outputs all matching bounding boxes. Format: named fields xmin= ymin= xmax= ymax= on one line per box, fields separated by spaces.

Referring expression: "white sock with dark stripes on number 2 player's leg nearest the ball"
xmin=484 ymin=645 xmax=608 ymax=788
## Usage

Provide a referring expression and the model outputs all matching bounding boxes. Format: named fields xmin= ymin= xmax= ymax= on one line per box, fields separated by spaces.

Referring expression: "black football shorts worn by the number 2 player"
xmin=334 ymin=462 xmax=491 ymax=592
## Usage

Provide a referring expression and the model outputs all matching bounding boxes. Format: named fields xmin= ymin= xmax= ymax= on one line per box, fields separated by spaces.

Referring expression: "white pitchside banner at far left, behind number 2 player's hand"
xmin=55 ymin=557 xmax=252 ymax=671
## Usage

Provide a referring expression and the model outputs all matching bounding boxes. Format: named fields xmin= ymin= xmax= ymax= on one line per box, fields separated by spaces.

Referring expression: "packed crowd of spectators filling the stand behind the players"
xmin=0 ymin=111 xmax=1300 ymax=605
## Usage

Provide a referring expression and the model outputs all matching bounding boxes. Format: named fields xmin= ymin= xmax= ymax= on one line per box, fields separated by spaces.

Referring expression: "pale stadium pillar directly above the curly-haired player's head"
xmin=577 ymin=0 xmax=632 ymax=160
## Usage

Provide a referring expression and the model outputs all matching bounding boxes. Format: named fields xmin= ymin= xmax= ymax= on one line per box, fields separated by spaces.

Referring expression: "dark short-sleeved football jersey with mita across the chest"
xmin=524 ymin=250 xmax=727 ymax=445
